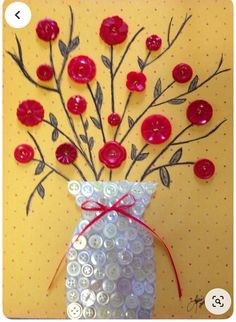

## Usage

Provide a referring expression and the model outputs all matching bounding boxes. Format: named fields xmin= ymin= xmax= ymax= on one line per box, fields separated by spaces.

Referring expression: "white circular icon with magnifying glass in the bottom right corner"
xmin=205 ymin=288 xmax=231 ymax=315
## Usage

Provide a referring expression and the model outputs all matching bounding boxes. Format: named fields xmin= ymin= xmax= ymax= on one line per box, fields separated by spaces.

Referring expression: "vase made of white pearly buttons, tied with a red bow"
xmin=66 ymin=181 xmax=156 ymax=319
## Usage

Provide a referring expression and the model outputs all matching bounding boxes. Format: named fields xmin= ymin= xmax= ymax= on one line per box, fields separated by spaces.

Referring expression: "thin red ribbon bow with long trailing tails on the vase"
xmin=48 ymin=193 xmax=182 ymax=298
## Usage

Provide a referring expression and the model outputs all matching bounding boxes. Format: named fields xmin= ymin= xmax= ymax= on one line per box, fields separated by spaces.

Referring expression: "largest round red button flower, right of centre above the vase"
xmin=141 ymin=114 xmax=171 ymax=144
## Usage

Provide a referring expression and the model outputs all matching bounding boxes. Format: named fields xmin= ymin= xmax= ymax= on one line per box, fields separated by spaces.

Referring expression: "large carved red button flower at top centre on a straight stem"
xmin=100 ymin=16 xmax=128 ymax=45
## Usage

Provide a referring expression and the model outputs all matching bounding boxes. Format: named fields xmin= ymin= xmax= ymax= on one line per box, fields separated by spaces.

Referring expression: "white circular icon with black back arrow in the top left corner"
xmin=5 ymin=1 xmax=31 ymax=29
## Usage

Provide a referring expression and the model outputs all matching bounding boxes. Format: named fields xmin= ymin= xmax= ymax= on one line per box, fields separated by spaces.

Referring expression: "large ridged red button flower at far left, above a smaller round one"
xmin=17 ymin=100 xmax=44 ymax=126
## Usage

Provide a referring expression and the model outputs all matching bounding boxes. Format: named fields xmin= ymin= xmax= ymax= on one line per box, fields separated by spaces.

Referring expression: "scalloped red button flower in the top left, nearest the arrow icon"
xmin=36 ymin=19 xmax=59 ymax=41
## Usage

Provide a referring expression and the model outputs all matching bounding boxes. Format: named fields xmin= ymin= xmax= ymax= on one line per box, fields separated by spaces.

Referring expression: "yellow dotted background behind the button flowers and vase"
xmin=3 ymin=0 xmax=233 ymax=318
